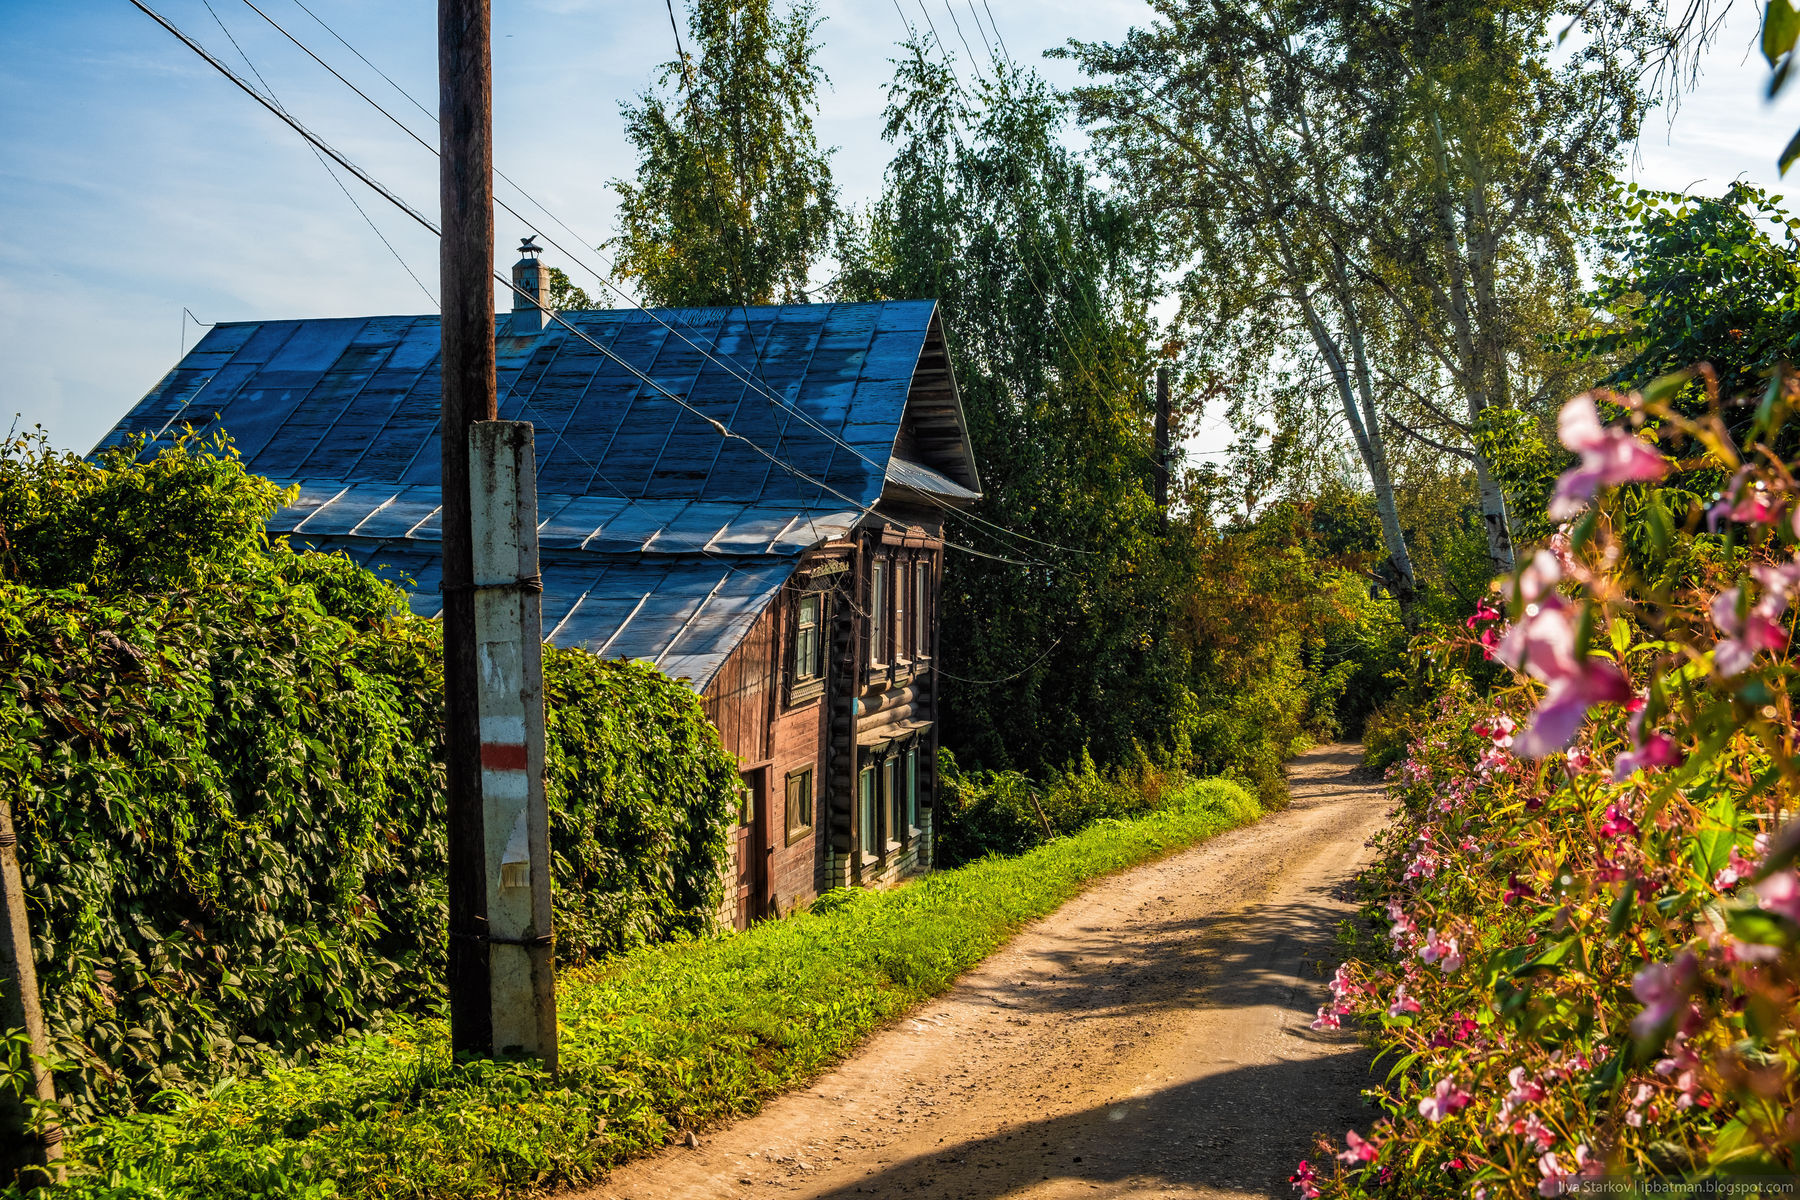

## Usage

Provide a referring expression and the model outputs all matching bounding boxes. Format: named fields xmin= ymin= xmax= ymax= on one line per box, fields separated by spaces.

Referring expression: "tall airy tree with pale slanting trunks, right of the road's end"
xmin=1064 ymin=0 xmax=1654 ymax=593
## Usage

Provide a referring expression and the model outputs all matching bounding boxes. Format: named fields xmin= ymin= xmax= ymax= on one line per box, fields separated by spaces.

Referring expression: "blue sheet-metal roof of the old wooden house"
xmin=95 ymin=300 xmax=977 ymax=687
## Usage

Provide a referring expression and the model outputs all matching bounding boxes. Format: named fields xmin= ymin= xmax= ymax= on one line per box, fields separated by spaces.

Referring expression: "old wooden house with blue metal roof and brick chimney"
xmin=99 ymin=255 xmax=979 ymax=927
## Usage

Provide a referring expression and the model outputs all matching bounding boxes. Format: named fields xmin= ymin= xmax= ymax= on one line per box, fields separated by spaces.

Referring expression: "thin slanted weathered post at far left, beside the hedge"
xmin=0 ymin=799 xmax=63 ymax=1186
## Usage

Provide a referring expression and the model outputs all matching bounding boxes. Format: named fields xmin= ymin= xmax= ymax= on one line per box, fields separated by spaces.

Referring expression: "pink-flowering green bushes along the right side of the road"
xmin=1296 ymin=396 xmax=1800 ymax=1196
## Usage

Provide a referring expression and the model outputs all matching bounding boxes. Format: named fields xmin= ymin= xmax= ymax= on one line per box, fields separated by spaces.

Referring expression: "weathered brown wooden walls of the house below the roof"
xmin=702 ymin=511 xmax=943 ymax=928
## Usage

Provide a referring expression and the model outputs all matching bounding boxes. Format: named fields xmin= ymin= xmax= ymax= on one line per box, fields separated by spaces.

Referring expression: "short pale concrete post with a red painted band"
xmin=470 ymin=421 xmax=556 ymax=1070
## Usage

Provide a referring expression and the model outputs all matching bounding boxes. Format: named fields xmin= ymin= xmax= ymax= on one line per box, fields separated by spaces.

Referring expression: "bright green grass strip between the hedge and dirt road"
xmin=35 ymin=781 xmax=1262 ymax=1198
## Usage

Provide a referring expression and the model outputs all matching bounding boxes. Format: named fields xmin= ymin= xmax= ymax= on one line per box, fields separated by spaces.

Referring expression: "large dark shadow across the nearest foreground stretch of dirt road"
xmin=802 ymin=1047 xmax=1373 ymax=1200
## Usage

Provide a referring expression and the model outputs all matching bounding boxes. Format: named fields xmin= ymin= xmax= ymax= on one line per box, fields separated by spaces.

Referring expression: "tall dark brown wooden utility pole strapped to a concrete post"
xmin=437 ymin=0 xmax=495 ymax=1054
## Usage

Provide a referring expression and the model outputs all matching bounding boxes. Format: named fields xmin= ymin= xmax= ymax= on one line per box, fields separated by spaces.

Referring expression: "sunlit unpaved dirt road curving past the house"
xmin=581 ymin=745 xmax=1386 ymax=1200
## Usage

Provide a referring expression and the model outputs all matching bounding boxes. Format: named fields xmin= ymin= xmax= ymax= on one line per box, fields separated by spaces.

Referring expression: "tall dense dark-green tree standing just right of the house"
xmin=837 ymin=36 xmax=1186 ymax=770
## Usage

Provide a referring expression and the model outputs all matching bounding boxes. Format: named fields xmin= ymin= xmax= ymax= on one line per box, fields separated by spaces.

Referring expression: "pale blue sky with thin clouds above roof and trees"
xmin=0 ymin=0 xmax=1800 ymax=453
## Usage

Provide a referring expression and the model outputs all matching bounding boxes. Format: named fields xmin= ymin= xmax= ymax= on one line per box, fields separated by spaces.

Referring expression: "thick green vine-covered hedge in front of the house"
xmin=0 ymin=439 xmax=736 ymax=1119
